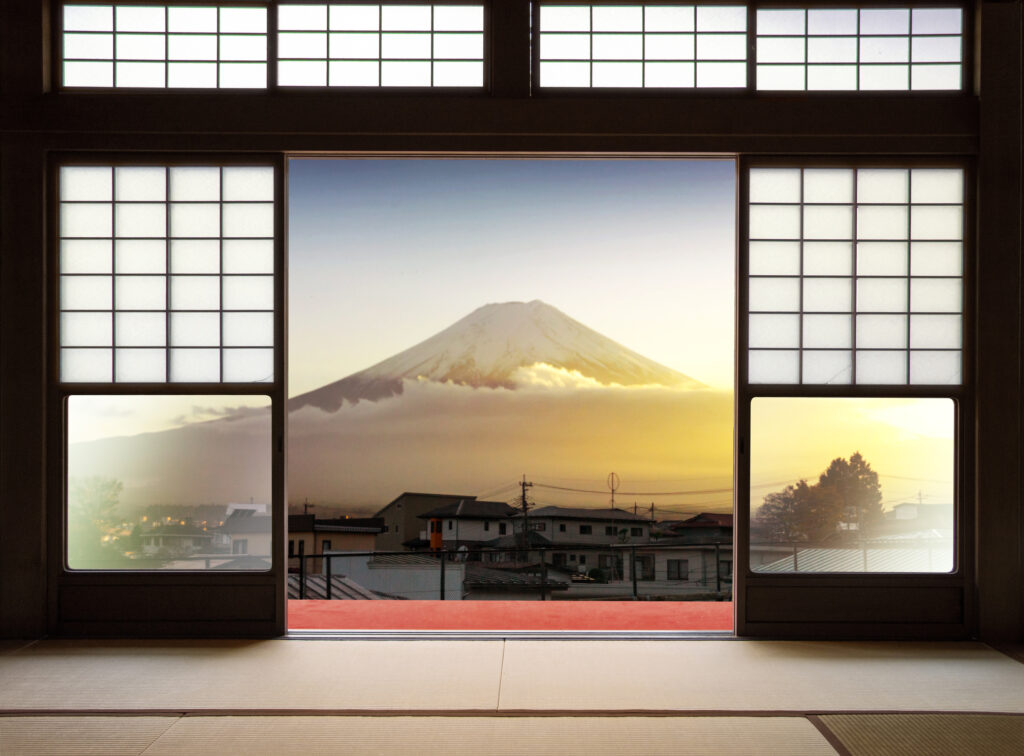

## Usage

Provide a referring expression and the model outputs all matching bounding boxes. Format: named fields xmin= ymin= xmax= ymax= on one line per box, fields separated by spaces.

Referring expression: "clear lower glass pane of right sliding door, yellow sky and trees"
xmin=751 ymin=397 xmax=955 ymax=573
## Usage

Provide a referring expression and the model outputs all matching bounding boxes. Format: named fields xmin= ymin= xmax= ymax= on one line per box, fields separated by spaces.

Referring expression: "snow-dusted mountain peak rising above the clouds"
xmin=288 ymin=299 xmax=703 ymax=412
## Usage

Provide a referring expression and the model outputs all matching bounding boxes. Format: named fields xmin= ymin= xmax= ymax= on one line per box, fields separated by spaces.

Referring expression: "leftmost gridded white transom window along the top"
xmin=61 ymin=3 xmax=267 ymax=89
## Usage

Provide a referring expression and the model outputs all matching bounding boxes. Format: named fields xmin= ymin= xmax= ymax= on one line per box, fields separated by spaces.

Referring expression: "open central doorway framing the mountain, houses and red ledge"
xmin=288 ymin=158 xmax=735 ymax=630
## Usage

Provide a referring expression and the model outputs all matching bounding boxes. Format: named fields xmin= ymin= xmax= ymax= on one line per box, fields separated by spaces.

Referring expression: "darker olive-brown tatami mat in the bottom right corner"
xmin=821 ymin=714 xmax=1024 ymax=756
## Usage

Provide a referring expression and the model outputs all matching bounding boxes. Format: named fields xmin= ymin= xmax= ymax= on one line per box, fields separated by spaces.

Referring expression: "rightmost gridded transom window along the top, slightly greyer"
xmin=757 ymin=7 xmax=964 ymax=90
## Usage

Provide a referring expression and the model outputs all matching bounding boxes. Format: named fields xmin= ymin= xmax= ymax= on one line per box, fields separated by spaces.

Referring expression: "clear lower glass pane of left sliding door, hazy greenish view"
xmin=67 ymin=391 xmax=271 ymax=571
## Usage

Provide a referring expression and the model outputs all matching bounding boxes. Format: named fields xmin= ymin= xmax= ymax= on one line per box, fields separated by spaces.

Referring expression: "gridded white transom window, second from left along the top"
xmin=278 ymin=2 xmax=484 ymax=87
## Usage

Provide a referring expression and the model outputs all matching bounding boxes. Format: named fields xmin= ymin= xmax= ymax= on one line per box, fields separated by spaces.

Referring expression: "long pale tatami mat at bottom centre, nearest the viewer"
xmin=145 ymin=717 xmax=836 ymax=756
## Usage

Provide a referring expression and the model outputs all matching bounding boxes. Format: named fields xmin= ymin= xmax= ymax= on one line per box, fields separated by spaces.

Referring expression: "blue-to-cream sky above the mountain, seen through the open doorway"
xmin=289 ymin=159 xmax=735 ymax=394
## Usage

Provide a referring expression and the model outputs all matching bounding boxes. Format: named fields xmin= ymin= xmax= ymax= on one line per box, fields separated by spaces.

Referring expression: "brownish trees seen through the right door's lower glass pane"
xmin=751 ymin=452 xmax=882 ymax=543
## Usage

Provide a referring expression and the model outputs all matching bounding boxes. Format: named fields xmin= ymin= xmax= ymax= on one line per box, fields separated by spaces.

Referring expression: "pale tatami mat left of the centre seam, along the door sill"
xmin=0 ymin=640 xmax=503 ymax=712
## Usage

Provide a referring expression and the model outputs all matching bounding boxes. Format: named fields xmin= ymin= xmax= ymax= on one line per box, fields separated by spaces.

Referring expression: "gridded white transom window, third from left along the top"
xmin=537 ymin=2 xmax=746 ymax=89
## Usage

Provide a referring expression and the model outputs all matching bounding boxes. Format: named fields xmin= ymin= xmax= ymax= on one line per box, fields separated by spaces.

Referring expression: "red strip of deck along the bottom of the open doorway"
xmin=288 ymin=600 xmax=732 ymax=630
